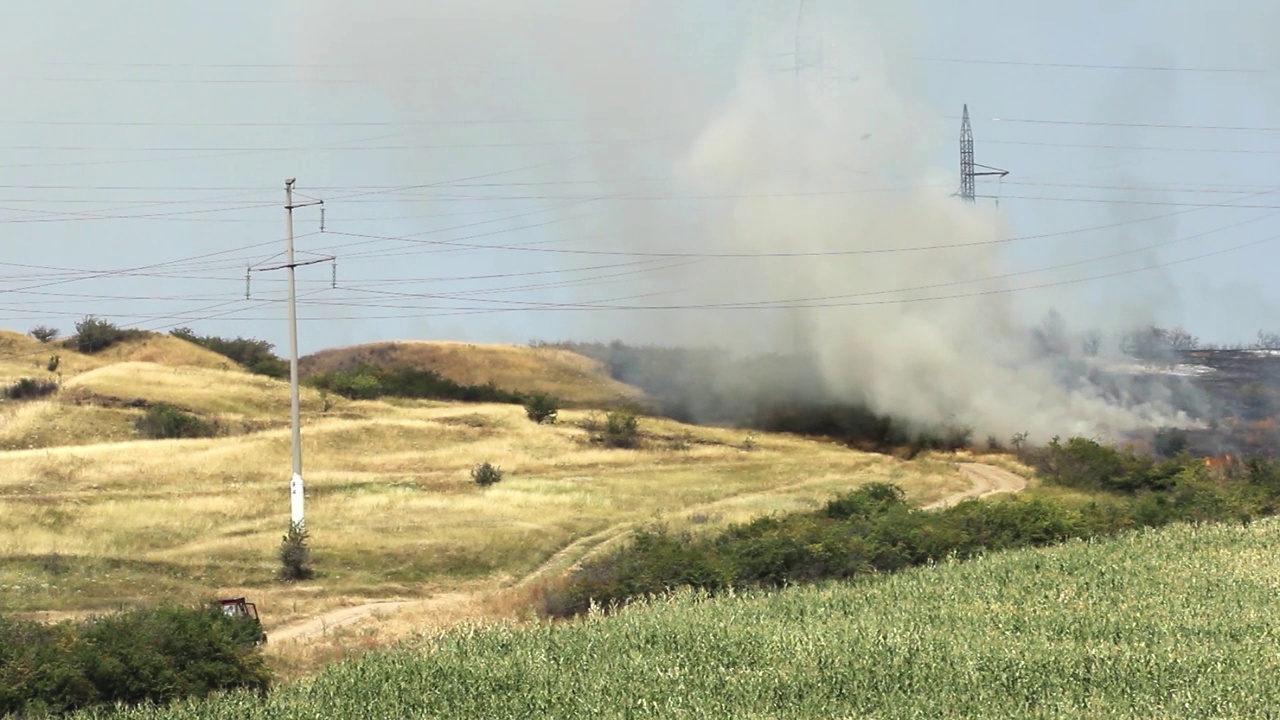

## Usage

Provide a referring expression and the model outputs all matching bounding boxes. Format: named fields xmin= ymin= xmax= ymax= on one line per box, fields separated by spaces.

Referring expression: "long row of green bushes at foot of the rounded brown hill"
xmin=308 ymin=365 xmax=525 ymax=404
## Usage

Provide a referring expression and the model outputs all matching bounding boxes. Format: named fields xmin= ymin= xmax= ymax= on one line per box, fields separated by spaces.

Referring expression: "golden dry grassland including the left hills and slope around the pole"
xmin=0 ymin=333 xmax=988 ymax=674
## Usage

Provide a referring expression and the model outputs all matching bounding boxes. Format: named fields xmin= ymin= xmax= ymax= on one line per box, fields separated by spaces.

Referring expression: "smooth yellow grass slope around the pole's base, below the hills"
xmin=0 ymin=405 xmax=965 ymax=626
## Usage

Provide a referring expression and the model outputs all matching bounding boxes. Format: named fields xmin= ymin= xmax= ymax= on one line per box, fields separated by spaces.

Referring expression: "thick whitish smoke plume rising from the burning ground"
xmin=299 ymin=0 xmax=1198 ymax=439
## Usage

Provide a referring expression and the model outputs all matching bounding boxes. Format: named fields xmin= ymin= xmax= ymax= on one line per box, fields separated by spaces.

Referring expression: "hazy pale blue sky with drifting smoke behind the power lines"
xmin=0 ymin=0 xmax=1280 ymax=352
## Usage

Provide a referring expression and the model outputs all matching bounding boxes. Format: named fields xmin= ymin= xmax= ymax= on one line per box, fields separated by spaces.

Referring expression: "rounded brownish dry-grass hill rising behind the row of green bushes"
xmin=298 ymin=341 xmax=643 ymax=407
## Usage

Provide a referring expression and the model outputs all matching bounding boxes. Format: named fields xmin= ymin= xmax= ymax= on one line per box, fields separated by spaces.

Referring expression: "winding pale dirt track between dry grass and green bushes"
xmin=268 ymin=462 xmax=1027 ymax=643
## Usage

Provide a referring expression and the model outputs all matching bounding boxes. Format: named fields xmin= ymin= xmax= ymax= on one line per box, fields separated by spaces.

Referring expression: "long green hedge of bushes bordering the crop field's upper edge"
xmin=543 ymin=438 xmax=1280 ymax=616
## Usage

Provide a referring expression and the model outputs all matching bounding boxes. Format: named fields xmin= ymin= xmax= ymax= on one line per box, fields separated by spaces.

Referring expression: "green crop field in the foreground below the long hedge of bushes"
xmin=77 ymin=520 xmax=1280 ymax=720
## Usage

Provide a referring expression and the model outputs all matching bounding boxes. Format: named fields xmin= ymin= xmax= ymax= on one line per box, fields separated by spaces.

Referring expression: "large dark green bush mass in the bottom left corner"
xmin=0 ymin=606 xmax=270 ymax=717
